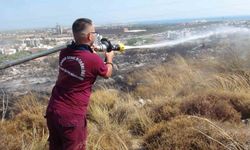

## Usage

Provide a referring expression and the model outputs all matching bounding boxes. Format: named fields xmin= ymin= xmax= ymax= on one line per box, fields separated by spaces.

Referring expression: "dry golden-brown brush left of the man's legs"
xmin=0 ymin=94 xmax=48 ymax=150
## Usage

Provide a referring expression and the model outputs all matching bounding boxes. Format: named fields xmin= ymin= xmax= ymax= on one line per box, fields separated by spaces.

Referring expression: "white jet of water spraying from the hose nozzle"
xmin=125 ymin=27 xmax=250 ymax=49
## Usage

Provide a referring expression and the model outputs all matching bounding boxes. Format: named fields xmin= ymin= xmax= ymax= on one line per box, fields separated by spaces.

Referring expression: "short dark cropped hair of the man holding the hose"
xmin=72 ymin=18 xmax=92 ymax=33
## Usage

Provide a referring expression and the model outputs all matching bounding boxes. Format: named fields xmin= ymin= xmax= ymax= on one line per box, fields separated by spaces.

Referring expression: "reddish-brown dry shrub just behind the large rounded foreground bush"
xmin=180 ymin=91 xmax=241 ymax=122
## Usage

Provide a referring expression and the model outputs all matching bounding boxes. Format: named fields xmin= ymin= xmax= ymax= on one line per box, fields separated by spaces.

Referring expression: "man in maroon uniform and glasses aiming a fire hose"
xmin=46 ymin=18 xmax=114 ymax=150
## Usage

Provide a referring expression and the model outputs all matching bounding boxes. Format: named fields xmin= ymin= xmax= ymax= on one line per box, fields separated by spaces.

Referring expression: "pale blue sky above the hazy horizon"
xmin=0 ymin=0 xmax=250 ymax=31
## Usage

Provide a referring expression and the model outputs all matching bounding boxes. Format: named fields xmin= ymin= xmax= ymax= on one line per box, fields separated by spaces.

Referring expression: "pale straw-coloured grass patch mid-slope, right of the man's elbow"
xmin=128 ymin=55 xmax=199 ymax=99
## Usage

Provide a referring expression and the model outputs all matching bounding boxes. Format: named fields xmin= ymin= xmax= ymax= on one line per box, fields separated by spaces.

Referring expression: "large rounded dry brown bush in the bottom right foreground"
xmin=144 ymin=116 xmax=246 ymax=150
